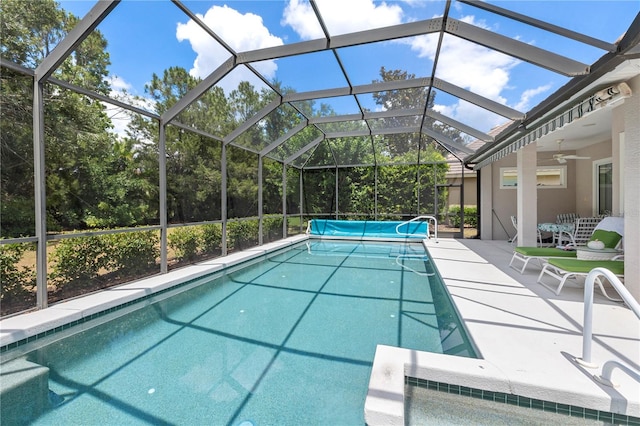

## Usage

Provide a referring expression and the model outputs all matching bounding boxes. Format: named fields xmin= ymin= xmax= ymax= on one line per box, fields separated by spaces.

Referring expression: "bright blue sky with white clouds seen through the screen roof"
xmin=60 ymin=0 xmax=640 ymax=131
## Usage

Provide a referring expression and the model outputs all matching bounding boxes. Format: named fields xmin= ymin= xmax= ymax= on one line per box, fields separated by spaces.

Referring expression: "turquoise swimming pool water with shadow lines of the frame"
xmin=5 ymin=240 xmax=475 ymax=426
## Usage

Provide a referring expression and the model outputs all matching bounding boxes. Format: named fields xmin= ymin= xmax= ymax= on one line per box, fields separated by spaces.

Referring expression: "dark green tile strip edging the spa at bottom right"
xmin=405 ymin=376 xmax=640 ymax=426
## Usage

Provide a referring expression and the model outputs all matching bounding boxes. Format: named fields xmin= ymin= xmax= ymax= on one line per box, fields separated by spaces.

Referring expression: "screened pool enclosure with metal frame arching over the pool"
xmin=0 ymin=0 xmax=638 ymax=315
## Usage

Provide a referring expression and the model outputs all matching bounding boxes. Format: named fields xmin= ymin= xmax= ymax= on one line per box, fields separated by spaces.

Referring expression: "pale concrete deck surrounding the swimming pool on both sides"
xmin=0 ymin=235 xmax=640 ymax=426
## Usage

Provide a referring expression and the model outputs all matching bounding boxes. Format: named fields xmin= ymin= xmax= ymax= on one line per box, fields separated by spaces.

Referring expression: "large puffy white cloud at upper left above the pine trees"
xmin=176 ymin=5 xmax=283 ymax=92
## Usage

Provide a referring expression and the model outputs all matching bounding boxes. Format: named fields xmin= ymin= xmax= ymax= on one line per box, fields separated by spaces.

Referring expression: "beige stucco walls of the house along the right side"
xmin=480 ymin=76 xmax=640 ymax=301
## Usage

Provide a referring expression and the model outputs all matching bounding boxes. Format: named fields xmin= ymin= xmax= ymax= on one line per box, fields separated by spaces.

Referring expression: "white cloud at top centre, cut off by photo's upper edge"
xmin=282 ymin=0 xmax=402 ymax=40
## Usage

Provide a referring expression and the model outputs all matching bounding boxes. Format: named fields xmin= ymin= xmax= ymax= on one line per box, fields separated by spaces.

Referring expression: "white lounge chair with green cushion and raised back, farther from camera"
xmin=509 ymin=218 xmax=624 ymax=274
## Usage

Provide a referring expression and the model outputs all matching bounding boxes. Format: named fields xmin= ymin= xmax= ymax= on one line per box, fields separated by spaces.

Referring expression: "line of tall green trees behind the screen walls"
xmin=0 ymin=0 xmax=459 ymax=237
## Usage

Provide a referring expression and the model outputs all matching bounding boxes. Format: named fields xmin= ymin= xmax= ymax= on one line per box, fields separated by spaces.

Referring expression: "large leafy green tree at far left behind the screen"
xmin=0 ymin=0 xmax=136 ymax=236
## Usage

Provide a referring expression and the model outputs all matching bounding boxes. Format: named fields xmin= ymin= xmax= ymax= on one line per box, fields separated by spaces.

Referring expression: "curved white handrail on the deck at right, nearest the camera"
xmin=576 ymin=268 xmax=640 ymax=368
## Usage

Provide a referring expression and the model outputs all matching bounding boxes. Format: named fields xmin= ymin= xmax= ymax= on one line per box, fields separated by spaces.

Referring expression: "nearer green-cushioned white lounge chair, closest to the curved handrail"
xmin=538 ymin=256 xmax=624 ymax=302
